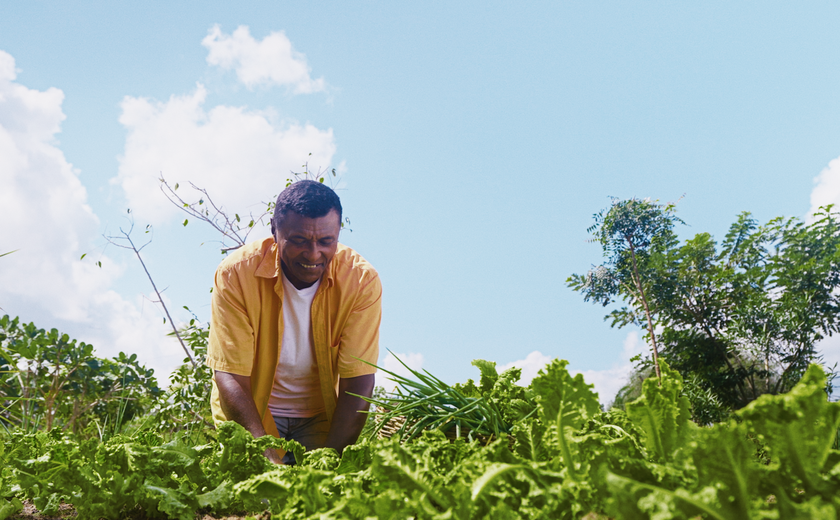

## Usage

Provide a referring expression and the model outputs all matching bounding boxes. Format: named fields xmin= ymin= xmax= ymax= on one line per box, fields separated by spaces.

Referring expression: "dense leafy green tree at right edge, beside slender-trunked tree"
xmin=569 ymin=200 xmax=840 ymax=409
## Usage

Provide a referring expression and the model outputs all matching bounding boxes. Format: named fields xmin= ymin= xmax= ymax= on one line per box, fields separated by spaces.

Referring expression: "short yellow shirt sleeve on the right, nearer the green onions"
xmin=338 ymin=273 xmax=382 ymax=379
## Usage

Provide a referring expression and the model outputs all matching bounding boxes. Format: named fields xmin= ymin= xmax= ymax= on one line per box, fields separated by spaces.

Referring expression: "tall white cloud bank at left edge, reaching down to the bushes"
xmin=0 ymin=51 xmax=181 ymax=378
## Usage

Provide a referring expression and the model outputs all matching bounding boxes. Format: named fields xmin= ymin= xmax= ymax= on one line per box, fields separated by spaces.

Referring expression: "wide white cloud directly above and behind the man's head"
xmin=112 ymin=84 xmax=335 ymax=224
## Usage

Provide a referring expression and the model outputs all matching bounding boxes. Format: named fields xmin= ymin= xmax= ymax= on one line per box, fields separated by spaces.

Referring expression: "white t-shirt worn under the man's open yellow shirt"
xmin=268 ymin=274 xmax=324 ymax=417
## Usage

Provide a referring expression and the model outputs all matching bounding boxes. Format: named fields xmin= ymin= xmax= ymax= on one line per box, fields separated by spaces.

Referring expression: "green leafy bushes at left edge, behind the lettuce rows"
xmin=0 ymin=316 xmax=161 ymax=435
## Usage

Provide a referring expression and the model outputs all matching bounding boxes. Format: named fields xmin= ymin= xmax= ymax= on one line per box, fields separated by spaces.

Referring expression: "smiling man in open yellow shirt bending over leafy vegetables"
xmin=207 ymin=181 xmax=382 ymax=463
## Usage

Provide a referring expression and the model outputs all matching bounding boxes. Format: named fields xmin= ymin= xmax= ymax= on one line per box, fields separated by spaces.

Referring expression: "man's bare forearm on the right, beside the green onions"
xmin=326 ymin=374 xmax=375 ymax=453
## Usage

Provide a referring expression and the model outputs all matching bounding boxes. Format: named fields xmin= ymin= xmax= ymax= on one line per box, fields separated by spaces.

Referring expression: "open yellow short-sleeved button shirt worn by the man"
xmin=207 ymin=237 xmax=382 ymax=437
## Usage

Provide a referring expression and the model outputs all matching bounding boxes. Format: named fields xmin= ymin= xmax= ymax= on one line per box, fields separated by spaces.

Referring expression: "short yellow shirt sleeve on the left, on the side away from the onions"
xmin=207 ymin=268 xmax=256 ymax=376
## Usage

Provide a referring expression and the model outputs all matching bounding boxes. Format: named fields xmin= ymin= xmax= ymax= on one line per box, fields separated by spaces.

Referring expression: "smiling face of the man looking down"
xmin=274 ymin=210 xmax=341 ymax=289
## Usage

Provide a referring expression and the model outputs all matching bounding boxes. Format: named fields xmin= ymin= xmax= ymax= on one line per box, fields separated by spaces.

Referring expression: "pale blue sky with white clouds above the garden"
xmin=0 ymin=1 xmax=840 ymax=400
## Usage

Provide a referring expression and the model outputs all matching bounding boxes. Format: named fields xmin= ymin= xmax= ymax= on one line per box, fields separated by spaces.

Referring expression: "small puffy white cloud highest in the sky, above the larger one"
xmin=201 ymin=25 xmax=326 ymax=94
